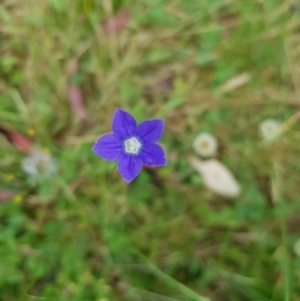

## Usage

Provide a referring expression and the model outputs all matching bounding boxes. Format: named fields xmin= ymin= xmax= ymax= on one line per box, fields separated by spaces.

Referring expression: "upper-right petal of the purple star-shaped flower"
xmin=136 ymin=119 xmax=164 ymax=143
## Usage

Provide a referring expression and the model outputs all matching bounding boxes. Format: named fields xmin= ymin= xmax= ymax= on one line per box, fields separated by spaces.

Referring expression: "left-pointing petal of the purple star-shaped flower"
xmin=92 ymin=134 xmax=122 ymax=161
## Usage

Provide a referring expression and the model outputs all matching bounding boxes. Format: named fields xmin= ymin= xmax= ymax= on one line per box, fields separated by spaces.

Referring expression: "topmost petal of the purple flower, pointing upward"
xmin=112 ymin=108 xmax=136 ymax=139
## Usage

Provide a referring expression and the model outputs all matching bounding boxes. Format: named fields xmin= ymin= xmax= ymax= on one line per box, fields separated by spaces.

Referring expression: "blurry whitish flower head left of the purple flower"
xmin=22 ymin=148 xmax=57 ymax=181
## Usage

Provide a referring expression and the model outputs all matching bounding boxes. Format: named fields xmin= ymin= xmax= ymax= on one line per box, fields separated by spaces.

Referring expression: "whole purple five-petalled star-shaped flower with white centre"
xmin=92 ymin=108 xmax=167 ymax=183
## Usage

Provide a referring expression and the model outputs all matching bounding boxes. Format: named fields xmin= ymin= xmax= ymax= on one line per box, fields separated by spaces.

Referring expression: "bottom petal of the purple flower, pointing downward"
xmin=118 ymin=155 xmax=143 ymax=183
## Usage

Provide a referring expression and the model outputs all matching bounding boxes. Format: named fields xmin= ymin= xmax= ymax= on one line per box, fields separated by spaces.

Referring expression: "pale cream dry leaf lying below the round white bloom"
xmin=190 ymin=157 xmax=240 ymax=198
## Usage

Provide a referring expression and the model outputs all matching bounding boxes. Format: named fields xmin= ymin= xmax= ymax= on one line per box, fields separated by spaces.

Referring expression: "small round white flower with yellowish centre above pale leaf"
xmin=193 ymin=133 xmax=218 ymax=157
